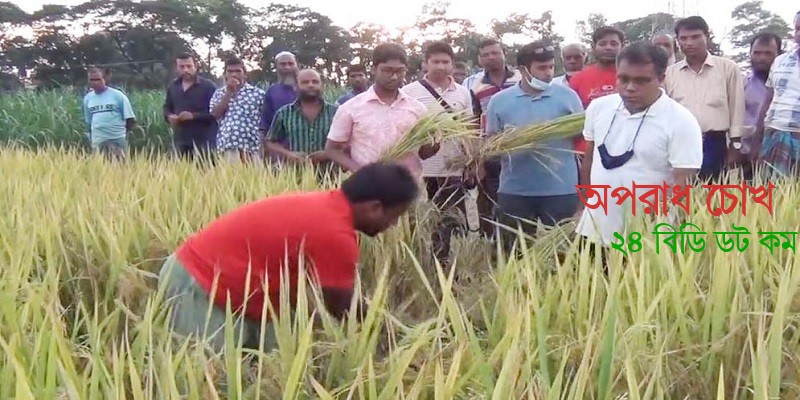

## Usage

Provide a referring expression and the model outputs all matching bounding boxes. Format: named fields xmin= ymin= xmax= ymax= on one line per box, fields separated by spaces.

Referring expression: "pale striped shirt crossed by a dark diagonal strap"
xmin=402 ymin=78 xmax=472 ymax=177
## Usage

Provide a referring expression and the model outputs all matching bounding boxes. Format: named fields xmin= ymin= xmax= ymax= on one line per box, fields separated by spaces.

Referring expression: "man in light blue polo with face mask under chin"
xmin=486 ymin=41 xmax=583 ymax=251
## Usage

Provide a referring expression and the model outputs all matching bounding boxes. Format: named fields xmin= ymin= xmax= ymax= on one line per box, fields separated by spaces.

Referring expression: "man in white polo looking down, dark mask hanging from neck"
xmin=577 ymin=43 xmax=703 ymax=250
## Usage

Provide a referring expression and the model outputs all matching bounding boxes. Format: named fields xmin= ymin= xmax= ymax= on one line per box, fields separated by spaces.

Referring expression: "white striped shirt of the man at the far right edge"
xmin=764 ymin=51 xmax=800 ymax=133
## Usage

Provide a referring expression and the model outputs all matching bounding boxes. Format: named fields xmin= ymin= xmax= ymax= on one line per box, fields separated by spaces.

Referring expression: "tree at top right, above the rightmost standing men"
xmin=728 ymin=0 xmax=791 ymax=62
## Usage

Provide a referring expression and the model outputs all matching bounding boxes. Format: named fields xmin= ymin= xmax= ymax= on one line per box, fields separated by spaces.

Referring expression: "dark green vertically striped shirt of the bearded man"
xmin=269 ymin=100 xmax=336 ymax=154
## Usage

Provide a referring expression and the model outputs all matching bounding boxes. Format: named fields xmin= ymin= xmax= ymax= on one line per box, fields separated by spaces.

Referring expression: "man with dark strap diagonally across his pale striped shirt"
xmin=402 ymin=42 xmax=473 ymax=263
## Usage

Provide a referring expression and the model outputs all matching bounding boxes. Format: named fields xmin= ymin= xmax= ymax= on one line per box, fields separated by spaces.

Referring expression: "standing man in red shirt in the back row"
xmin=569 ymin=26 xmax=625 ymax=160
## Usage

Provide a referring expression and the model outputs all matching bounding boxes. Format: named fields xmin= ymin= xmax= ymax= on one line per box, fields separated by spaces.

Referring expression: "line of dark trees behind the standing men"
xmin=0 ymin=0 xmax=790 ymax=90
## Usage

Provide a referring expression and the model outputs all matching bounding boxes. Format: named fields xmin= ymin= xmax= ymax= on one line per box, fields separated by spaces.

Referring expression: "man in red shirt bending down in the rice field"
xmin=159 ymin=163 xmax=419 ymax=350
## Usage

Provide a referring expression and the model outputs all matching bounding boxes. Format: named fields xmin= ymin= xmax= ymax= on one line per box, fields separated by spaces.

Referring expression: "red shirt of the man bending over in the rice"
xmin=177 ymin=190 xmax=359 ymax=320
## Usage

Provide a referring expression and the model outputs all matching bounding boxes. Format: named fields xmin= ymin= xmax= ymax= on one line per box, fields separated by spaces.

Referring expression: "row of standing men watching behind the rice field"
xmin=84 ymin=16 xmax=800 ymax=259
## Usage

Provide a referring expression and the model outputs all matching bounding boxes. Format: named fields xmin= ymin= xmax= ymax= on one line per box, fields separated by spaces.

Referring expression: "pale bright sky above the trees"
xmin=12 ymin=0 xmax=800 ymax=51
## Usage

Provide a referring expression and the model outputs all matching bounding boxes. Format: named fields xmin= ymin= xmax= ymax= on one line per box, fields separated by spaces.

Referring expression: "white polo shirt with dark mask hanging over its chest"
xmin=577 ymin=89 xmax=703 ymax=246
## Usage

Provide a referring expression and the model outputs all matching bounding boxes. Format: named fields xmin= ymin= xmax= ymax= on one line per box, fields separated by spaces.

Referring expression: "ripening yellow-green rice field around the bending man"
xmin=0 ymin=94 xmax=800 ymax=400
